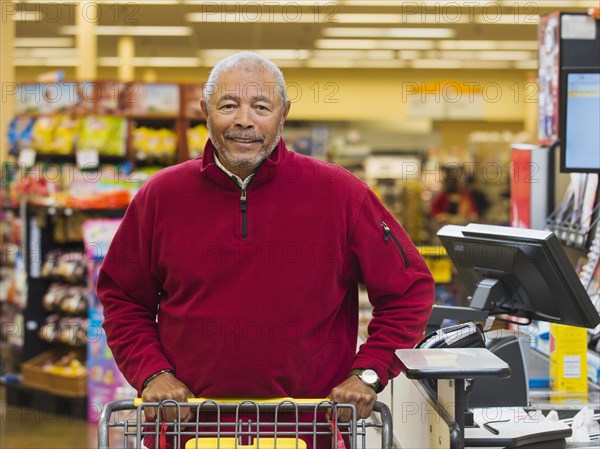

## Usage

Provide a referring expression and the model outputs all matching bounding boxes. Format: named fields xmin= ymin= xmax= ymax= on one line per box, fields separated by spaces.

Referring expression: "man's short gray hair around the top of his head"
xmin=204 ymin=51 xmax=287 ymax=108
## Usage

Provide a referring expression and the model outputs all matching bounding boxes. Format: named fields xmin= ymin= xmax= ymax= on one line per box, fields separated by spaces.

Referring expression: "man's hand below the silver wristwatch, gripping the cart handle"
xmin=327 ymin=376 xmax=377 ymax=422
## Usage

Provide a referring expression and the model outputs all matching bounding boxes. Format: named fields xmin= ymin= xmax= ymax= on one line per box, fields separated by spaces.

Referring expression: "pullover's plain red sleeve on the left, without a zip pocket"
xmin=97 ymin=192 xmax=173 ymax=392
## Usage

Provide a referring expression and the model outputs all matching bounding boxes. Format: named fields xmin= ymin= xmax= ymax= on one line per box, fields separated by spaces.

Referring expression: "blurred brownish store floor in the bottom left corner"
xmin=0 ymin=387 xmax=97 ymax=449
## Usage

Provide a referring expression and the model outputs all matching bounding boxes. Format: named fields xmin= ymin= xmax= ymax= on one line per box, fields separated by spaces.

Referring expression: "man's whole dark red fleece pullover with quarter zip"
xmin=98 ymin=141 xmax=434 ymax=398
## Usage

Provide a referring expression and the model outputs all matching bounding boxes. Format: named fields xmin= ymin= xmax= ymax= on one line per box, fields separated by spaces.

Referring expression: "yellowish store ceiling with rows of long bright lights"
xmin=9 ymin=0 xmax=598 ymax=68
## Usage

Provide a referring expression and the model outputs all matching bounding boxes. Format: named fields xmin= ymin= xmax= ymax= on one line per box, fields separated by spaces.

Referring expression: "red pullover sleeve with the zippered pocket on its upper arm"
xmin=349 ymin=190 xmax=435 ymax=386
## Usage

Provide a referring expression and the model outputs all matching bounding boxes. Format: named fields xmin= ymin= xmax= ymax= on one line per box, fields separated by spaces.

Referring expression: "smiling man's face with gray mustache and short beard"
xmin=201 ymin=69 xmax=290 ymax=177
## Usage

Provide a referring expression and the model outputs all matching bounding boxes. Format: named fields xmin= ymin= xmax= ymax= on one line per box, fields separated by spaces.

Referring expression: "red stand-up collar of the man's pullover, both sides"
xmin=201 ymin=139 xmax=289 ymax=190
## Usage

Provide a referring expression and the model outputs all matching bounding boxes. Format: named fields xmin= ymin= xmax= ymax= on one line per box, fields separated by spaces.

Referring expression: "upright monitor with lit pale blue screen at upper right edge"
xmin=560 ymin=68 xmax=600 ymax=172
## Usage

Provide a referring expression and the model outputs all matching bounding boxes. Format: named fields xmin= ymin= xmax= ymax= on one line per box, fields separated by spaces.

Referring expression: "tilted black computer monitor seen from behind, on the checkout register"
xmin=437 ymin=224 xmax=600 ymax=328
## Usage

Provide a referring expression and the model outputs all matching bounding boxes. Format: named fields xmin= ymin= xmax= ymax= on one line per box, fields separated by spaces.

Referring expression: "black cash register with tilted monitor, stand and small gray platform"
xmin=397 ymin=224 xmax=600 ymax=448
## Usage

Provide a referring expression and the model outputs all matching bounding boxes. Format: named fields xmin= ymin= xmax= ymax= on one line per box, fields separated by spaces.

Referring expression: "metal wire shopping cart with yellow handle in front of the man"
xmin=98 ymin=398 xmax=392 ymax=449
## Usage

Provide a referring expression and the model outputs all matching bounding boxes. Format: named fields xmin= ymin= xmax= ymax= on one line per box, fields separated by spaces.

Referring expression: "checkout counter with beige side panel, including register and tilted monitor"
xmin=368 ymin=224 xmax=600 ymax=449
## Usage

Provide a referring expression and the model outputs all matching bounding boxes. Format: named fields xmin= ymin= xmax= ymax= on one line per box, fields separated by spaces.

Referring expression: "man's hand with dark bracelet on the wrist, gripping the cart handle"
xmin=142 ymin=372 xmax=194 ymax=421
